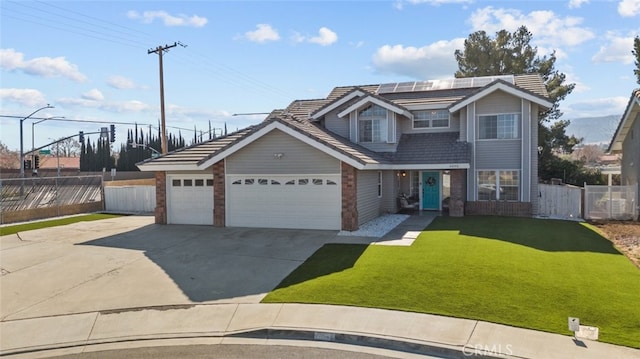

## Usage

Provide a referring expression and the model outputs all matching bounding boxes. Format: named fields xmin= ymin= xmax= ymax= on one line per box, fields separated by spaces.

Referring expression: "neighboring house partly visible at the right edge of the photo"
xmin=607 ymin=89 xmax=640 ymax=219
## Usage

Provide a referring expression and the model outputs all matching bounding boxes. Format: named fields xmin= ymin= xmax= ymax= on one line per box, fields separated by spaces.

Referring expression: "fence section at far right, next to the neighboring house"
xmin=584 ymin=185 xmax=638 ymax=220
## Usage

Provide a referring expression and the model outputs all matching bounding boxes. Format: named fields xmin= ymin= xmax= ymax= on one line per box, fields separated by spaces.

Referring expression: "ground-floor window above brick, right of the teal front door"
xmin=478 ymin=171 xmax=520 ymax=201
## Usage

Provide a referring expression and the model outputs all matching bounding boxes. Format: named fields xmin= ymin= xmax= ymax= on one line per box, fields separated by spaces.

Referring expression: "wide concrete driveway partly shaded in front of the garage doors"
xmin=0 ymin=216 xmax=363 ymax=320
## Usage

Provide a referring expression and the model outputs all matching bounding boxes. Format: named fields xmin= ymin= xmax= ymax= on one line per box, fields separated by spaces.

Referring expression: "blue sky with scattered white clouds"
xmin=0 ymin=0 xmax=640 ymax=151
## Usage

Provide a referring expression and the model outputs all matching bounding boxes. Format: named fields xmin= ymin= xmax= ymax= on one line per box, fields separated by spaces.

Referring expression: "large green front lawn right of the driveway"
xmin=263 ymin=217 xmax=640 ymax=348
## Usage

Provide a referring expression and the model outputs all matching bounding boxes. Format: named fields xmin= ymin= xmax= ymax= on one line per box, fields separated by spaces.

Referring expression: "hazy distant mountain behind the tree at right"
xmin=565 ymin=115 xmax=622 ymax=144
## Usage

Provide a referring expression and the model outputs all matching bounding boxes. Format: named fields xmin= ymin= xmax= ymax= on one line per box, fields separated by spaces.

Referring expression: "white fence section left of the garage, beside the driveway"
xmin=104 ymin=186 xmax=156 ymax=213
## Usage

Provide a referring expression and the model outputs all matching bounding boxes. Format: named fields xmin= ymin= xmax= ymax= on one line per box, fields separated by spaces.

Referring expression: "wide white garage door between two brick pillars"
xmin=226 ymin=175 xmax=341 ymax=230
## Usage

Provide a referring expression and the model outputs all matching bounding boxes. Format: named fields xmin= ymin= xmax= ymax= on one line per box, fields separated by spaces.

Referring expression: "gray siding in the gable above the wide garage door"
xmin=226 ymin=130 xmax=340 ymax=174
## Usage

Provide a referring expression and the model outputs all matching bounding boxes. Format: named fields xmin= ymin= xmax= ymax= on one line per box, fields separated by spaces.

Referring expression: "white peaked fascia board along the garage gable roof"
xmin=197 ymin=121 xmax=364 ymax=170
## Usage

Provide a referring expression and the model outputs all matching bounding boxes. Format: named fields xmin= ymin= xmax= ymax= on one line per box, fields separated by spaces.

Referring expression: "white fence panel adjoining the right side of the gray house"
xmin=538 ymin=183 xmax=582 ymax=219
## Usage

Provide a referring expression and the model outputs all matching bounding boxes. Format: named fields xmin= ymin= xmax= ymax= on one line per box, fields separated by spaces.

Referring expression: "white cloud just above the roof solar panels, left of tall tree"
xmin=373 ymin=38 xmax=464 ymax=79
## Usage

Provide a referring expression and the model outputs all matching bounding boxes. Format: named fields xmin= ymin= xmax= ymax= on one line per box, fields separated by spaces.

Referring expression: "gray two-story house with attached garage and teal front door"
xmin=138 ymin=75 xmax=552 ymax=231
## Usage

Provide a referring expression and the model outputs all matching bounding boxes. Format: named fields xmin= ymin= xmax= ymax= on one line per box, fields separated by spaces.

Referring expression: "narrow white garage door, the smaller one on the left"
xmin=167 ymin=175 xmax=213 ymax=225
